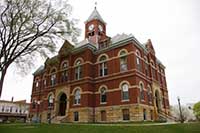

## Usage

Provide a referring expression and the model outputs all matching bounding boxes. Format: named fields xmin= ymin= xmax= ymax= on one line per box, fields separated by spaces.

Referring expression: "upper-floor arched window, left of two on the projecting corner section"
xmin=99 ymin=55 xmax=108 ymax=76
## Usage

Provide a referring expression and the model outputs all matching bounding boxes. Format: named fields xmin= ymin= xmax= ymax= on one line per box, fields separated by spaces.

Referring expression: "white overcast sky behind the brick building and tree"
xmin=1 ymin=0 xmax=200 ymax=104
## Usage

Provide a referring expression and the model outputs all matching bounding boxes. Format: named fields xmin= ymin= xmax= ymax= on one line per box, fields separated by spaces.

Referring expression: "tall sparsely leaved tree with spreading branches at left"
xmin=0 ymin=0 xmax=79 ymax=96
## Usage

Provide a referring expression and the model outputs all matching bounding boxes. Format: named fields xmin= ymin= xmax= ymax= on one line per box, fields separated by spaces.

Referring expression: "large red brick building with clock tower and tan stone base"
xmin=30 ymin=8 xmax=169 ymax=122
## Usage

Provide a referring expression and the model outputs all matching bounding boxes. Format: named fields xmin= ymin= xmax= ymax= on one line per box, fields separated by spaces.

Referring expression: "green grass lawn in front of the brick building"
xmin=0 ymin=123 xmax=200 ymax=133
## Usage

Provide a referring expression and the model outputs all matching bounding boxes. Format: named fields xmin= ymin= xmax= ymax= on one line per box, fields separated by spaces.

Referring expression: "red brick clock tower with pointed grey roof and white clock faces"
xmin=85 ymin=7 xmax=109 ymax=48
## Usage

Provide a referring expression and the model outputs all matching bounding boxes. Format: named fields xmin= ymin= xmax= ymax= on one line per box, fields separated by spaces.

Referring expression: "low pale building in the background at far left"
xmin=0 ymin=99 xmax=30 ymax=122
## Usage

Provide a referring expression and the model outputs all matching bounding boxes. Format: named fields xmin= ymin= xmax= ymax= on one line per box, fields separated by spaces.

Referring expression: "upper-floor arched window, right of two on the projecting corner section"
xmin=120 ymin=50 xmax=127 ymax=71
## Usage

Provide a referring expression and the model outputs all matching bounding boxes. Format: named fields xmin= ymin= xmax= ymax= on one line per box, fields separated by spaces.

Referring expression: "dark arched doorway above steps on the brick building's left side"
xmin=58 ymin=93 xmax=67 ymax=116
